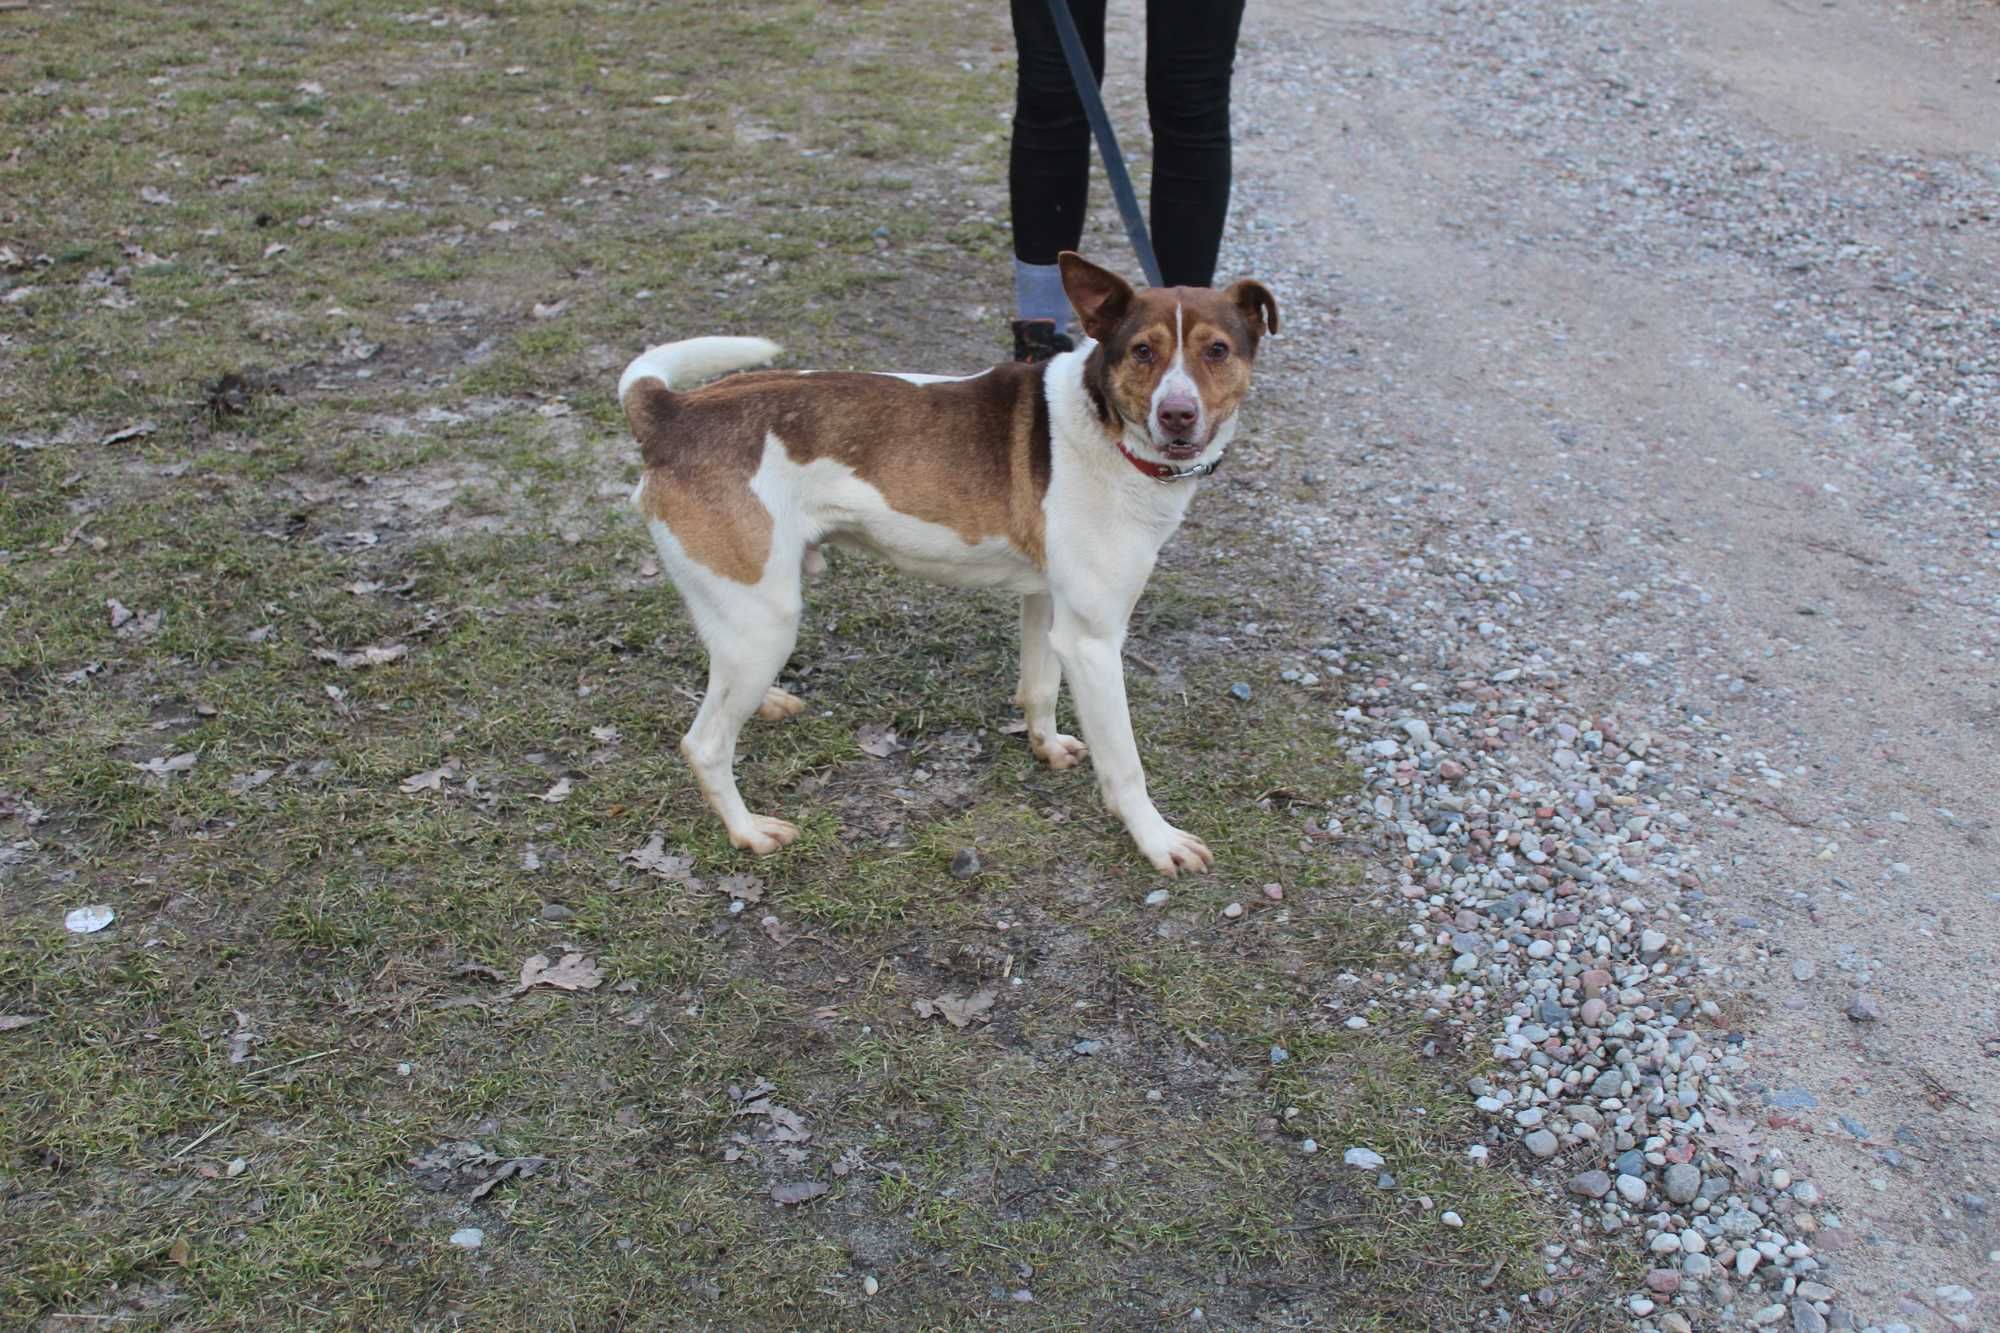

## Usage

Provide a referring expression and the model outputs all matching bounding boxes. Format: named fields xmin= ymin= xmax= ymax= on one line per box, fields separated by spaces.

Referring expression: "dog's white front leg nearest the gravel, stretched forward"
xmin=1056 ymin=598 xmax=1216 ymax=875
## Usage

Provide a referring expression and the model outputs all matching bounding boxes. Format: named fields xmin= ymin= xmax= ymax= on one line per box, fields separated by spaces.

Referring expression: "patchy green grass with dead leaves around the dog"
xmin=0 ymin=0 xmax=1576 ymax=1327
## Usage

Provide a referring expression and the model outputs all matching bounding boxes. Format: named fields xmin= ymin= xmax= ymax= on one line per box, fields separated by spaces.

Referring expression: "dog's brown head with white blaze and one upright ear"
xmin=1058 ymin=250 xmax=1278 ymax=462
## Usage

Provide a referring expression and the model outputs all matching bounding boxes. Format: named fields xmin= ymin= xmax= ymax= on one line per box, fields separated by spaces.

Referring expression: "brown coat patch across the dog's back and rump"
xmin=626 ymin=364 xmax=1050 ymax=582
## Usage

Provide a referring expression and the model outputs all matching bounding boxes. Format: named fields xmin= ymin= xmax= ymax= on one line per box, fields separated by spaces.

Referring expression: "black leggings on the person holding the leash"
xmin=1008 ymin=0 xmax=1244 ymax=286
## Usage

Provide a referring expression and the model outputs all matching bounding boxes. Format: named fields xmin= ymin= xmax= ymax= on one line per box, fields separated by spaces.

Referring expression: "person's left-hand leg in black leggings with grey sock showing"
xmin=1008 ymin=0 xmax=1104 ymax=354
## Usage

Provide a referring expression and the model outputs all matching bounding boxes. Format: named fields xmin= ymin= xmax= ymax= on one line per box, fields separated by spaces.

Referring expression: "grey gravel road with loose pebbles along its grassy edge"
xmin=1176 ymin=0 xmax=2000 ymax=1329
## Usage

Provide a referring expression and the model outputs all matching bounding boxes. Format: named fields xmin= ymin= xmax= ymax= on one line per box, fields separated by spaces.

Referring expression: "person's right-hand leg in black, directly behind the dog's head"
xmin=1146 ymin=0 xmax=1244 ymax=286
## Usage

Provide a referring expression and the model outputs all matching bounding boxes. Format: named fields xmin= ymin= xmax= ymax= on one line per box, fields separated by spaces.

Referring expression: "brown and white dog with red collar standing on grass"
xmin=618 ymin=254 xmax=1278 ymax=875
